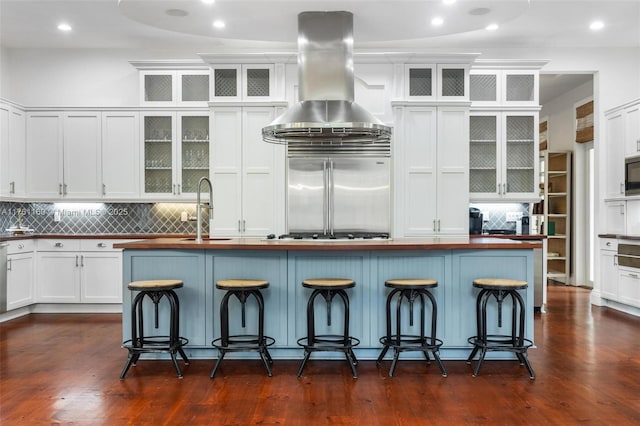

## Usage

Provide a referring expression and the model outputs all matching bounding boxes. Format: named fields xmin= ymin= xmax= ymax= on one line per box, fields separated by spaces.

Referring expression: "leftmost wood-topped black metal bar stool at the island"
xmin=120 ymin=280 xmax=189 ymax=379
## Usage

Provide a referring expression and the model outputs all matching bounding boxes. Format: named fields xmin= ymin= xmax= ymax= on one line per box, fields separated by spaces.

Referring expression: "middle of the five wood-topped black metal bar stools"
xmin=298 ymin=278 xmax=360 ymax=378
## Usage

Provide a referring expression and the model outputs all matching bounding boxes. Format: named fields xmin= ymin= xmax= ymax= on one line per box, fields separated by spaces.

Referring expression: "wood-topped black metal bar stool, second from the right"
xmin=376 ymin=279 xmax=447 ymax=377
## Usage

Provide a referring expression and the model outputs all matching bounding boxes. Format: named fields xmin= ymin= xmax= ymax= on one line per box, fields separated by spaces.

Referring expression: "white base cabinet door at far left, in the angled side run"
xmin=7 ymin=252 xmax=33 ymax=310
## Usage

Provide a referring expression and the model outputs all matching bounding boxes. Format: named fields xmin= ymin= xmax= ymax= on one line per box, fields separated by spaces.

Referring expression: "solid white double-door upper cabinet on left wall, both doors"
xmin=27 ymin=111 xmax=101 ymax=199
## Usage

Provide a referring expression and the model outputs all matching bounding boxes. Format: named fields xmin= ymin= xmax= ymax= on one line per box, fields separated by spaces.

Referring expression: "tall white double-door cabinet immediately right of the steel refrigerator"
xmin=394 ymin=106 xmax=469 ymax=237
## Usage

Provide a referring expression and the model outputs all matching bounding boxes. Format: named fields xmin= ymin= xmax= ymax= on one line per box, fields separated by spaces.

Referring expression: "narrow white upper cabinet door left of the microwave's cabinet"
xmin=600 ymin=111 xmax=625 ymax=199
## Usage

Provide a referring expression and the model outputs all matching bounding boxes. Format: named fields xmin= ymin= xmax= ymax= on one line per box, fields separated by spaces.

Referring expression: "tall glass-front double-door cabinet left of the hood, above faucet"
xmin=140 ymin=111 xmax=211 ymax=199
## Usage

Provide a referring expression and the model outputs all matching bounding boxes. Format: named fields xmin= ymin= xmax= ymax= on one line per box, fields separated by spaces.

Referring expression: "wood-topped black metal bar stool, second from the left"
xmin=210 ymin=279 xmax=275 ymax=379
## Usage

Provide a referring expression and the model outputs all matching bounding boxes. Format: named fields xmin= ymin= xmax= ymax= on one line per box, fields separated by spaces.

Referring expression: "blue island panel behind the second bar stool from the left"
xmin=205 ymin=251 xmax=288 ymax=348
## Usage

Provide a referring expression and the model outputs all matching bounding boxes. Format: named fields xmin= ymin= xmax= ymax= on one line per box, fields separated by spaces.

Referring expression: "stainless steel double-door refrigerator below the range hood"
xmin=287 ymin=156 xmax=390 ymax=235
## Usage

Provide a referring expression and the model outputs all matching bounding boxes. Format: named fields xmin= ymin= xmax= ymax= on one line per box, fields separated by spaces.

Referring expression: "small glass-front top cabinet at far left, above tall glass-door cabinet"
xmin=140 ymin=69 xmax=210 ymax=106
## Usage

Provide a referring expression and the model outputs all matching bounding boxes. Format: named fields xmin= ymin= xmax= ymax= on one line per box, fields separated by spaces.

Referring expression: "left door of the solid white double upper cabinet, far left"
xmin=27 ymin=112 xmax=63 ymax=198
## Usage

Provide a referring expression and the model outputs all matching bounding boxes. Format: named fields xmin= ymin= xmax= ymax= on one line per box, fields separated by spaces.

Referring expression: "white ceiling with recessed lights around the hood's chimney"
xmin=0 ymin=0 xmax=640 ymax=98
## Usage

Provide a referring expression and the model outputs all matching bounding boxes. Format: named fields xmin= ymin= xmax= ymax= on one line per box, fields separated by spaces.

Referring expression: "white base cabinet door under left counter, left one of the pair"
xmin=36 ymin=252 xmax=80 ymax=303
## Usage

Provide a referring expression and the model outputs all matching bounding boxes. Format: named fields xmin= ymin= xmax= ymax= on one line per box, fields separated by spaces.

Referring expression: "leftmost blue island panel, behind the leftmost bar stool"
xmin=122 ymin=250 xmax=206 ymax=348
